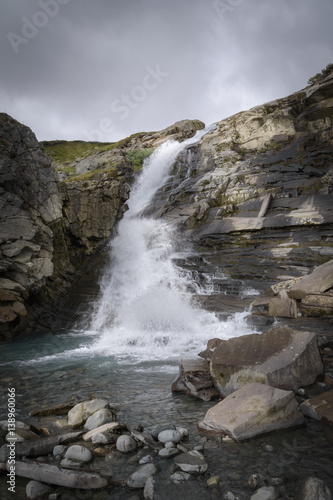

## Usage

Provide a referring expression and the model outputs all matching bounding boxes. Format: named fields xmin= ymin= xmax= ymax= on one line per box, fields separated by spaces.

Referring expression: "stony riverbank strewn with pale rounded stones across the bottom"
xmin=0 ymin=384 xmax=333 ymax=500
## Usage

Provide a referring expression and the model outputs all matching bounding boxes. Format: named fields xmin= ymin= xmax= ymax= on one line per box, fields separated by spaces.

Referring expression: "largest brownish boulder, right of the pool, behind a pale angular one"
xmin=210 ymin=327 xmax=324 ymax=397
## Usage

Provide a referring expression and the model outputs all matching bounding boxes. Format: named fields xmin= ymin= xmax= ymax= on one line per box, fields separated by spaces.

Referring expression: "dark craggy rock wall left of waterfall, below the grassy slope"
xmin=0 ymin=114 xmax=133 ymax=339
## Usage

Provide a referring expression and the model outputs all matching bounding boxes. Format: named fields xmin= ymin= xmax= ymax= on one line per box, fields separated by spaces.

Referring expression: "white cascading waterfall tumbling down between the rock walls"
xmin=90 ymin=130 xmax=253 ymax=361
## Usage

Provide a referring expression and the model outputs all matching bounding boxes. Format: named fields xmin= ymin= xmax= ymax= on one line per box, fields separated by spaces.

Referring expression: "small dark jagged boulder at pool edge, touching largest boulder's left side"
xmin=171 ymin=359 xmax=219 ymax=401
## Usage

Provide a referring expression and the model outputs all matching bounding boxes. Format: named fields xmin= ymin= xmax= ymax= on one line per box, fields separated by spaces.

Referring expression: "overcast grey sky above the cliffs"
xmin=0 ymin=0 xmax=333 ymax=141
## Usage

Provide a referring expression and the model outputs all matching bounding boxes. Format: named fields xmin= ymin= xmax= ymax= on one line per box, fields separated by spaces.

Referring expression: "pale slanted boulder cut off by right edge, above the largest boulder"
xmin=289 ymin=260 xmax=333 ymax=299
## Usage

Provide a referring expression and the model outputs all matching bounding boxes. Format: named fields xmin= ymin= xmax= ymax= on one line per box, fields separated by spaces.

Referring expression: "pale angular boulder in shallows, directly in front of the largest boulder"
xmin=199 ymin=382 xmax=304 ymax=441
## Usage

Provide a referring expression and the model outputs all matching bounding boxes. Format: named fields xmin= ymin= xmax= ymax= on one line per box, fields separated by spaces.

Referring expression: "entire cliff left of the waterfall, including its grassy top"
xmin=0 ymin=114 xmax=204 ymax=339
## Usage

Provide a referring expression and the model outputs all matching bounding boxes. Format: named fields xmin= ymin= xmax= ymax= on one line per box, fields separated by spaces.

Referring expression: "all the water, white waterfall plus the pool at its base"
xmin=0 ymin=130 xmax=333 ymax=498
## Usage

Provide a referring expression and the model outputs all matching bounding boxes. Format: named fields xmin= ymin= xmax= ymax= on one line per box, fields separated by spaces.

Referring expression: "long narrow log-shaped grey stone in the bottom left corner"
xmin=9 ymin=460 xmax=108 ymax=490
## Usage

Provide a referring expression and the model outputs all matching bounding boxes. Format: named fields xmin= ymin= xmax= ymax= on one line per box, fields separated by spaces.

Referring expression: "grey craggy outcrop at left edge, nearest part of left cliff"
xmin=0 ymin=114 xmax=62 ymax=331
